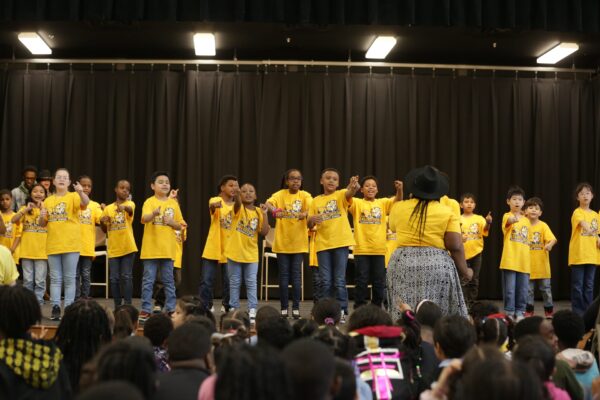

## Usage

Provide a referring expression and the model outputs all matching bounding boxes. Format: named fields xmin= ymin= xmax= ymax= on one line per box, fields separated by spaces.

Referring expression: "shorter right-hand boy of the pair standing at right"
xmin=523 ymin=197 xmax=556 ymax=318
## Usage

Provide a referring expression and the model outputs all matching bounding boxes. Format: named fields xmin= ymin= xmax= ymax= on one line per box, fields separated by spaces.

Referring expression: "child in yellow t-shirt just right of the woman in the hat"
xmin=460 ymin=193 xmax=492 ymax=310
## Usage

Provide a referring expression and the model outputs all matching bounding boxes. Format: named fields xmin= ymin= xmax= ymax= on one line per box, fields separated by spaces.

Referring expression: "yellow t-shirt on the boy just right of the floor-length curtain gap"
xmin=202 ymin=196 xmax=233 ymax=264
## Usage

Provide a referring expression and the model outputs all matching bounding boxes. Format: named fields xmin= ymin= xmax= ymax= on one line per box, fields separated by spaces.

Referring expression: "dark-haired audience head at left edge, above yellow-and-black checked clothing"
xmin=0 ymin=285 xmax=42 ymax=338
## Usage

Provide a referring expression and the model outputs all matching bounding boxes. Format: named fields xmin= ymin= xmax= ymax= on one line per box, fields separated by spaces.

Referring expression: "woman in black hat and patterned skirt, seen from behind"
xmin=387 ymin=166 xmax=473 ymax=319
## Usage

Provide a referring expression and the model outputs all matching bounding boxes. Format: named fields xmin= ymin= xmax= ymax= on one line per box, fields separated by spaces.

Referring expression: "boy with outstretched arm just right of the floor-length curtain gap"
xmin=200 ymin=175 xmax=239 ymax=312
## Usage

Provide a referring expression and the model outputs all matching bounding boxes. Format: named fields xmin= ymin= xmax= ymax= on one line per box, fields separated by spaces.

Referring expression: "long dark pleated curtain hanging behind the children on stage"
xmin=0 ymin=70 xmax=600 ymax=298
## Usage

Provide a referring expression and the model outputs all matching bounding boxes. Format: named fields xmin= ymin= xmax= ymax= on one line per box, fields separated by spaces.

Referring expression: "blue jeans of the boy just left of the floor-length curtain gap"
xmin=142 ymin=258 xmax=177 ymax=313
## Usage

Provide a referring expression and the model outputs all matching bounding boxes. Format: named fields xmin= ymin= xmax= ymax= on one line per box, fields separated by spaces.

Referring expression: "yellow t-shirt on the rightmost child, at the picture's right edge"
xmin=569 ymin=208 xmax=600 ymax=265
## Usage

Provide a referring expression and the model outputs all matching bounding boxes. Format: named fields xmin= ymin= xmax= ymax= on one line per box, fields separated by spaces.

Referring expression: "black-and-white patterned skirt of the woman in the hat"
xmin=387 ymin=247 xmax=467 ymax=321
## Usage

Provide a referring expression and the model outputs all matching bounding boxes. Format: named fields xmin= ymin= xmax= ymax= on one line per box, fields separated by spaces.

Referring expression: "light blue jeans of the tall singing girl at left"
xmin=48 ymin=253 xmax=79 ymax=307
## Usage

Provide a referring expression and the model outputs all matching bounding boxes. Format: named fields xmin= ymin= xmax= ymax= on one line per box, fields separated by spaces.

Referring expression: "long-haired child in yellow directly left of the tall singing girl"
xmin=12 ymin=183 xmax=48 ymax=305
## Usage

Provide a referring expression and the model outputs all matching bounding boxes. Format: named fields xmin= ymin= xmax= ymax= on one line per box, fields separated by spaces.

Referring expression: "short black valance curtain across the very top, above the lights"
xmin=0 ymin=0 xmax=600 ymax=32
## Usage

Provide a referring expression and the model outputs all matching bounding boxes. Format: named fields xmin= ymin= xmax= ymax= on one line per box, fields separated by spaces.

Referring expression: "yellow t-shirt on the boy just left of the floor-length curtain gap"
xmin=140 ymin=196 xmax=183 ymax=260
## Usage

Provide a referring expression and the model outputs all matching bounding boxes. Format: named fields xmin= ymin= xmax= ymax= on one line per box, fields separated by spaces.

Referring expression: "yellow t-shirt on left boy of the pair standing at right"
xmin=500 ymin=212 xmax=531 ymax=274
